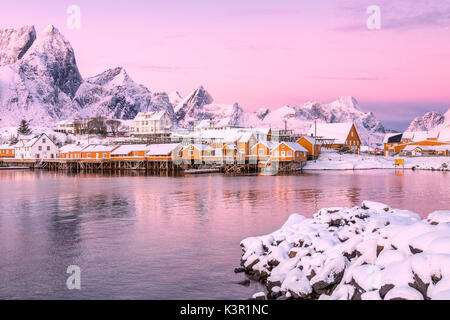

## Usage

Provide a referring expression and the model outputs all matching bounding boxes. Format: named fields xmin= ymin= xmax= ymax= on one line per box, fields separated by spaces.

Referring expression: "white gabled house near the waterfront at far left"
xmin=14 ymin=133 xmax=58 ymax=159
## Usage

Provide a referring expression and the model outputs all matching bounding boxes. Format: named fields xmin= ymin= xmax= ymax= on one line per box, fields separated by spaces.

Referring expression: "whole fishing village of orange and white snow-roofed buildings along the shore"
xmin=0 ymin=111 xmax=450 ymax=175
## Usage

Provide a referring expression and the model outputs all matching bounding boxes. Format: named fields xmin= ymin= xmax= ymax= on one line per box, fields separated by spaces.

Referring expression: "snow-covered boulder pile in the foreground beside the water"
xmin=241 ymin=201 xmax=450 ymax=300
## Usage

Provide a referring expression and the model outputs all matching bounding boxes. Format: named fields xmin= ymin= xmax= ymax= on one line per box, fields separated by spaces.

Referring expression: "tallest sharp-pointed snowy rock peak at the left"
xmin=0 ymin=25 xmax=82 ymax=125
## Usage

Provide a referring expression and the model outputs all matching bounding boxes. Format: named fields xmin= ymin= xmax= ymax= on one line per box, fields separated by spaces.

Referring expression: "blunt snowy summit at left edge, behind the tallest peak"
xmin=0 ymin=26 xmax=36 ymax=66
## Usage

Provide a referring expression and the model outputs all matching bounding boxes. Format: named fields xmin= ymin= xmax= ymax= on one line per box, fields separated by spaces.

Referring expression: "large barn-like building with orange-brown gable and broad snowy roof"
xmin=308 ymin=122 xmax=361 ymax=152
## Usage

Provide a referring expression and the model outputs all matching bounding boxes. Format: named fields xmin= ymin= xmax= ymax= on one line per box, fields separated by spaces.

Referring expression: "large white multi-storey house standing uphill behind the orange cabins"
xmin=130 ymin=111 xmax=173 ymax=136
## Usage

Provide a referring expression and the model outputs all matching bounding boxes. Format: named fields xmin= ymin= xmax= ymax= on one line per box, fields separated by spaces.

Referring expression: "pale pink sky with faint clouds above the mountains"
xmin=0 ymin=0 xmax=450 ymax=130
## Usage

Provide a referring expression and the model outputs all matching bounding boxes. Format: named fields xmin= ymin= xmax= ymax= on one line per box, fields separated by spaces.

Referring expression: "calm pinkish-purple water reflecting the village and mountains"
xmin=0 ymin=170 xmax=450 ymax=299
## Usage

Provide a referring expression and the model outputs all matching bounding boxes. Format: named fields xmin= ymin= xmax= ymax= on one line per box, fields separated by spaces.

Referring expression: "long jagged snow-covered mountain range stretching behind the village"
xmin=0 ymin=25 xmax=385 ymax=142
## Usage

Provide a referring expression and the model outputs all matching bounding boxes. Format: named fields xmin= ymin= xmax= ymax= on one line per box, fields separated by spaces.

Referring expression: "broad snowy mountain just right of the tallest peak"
xmin=73 ymin=67 xmax=174 ymax=120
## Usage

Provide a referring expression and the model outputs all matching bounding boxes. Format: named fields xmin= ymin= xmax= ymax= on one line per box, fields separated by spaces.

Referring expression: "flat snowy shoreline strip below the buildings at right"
xmin=304 ymin=149 xmax=450 ymax=171
